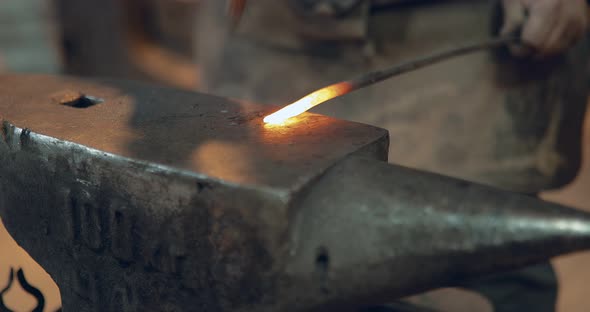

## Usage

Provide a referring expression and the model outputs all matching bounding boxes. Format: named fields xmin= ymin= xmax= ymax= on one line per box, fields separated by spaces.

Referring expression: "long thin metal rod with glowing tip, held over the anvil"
xmin=264 ymin=37 xmax=518 ymax=125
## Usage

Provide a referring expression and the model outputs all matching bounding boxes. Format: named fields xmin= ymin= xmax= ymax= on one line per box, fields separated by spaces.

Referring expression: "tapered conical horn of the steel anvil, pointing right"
xmin=288 ymin=158 xmax=590 ymax=311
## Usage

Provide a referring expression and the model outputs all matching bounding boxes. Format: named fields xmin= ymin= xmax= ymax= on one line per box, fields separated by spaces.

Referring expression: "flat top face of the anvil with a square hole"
xmin=0 ymin=76 xmax=388 ymax=191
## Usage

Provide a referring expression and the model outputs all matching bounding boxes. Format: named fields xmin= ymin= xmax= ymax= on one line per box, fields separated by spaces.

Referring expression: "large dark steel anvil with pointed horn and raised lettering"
xmin=0 ymin=75 xmax=590 ymax=312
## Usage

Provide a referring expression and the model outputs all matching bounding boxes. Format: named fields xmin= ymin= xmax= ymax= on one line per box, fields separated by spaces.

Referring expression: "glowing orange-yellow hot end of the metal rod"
xmin=264 ymin=82 xmax=352 ymax=125
